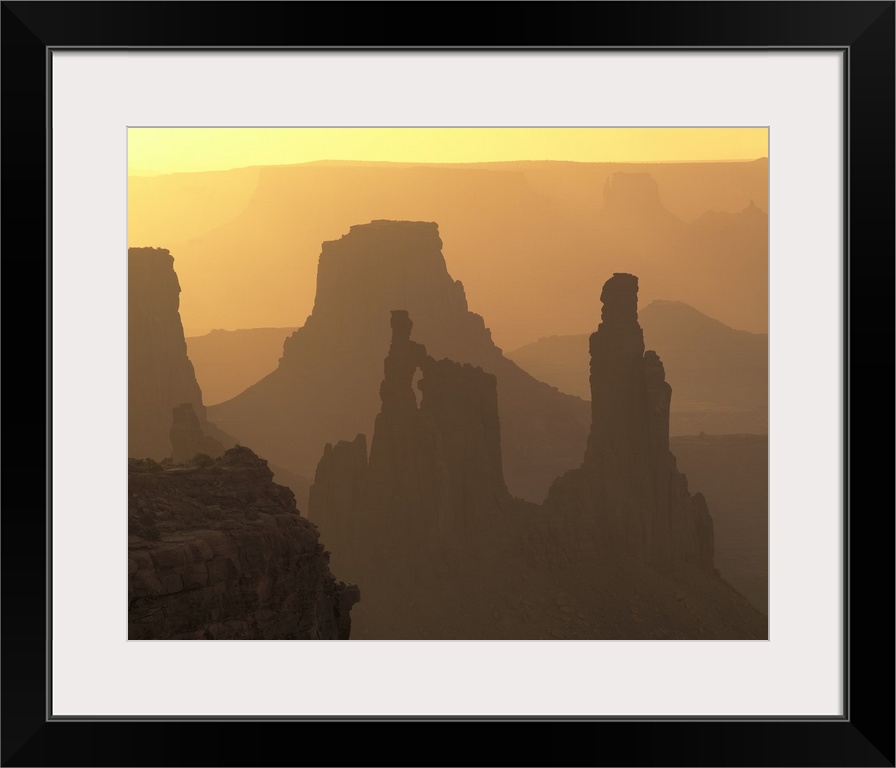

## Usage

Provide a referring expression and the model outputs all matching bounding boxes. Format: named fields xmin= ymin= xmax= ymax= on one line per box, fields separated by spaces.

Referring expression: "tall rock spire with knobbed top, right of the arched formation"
xmin=545 ymin=273 xmax=713 ymax=572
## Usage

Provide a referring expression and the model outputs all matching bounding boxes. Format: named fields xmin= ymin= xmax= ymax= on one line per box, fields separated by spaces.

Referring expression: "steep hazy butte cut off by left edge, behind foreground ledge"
xmin=128 ymin=248 xmax=233 ymax=461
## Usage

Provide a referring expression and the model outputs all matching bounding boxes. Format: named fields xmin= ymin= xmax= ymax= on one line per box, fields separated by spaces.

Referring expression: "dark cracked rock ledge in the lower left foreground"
xmin=128 ymin=447 xmax=360 ymax=640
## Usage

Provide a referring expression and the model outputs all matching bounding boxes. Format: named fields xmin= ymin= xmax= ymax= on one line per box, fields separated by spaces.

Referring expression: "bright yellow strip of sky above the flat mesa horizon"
xmin=128 ymin=128 xmax=768 ymax=174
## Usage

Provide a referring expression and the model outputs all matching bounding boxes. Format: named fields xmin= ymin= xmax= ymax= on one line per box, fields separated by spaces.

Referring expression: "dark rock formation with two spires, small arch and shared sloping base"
xmin=309 ymin=300 xmax=767 ymax=639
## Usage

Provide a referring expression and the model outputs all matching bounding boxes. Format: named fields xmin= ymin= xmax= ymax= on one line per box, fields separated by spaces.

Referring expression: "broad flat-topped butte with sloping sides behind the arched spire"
xmin=209 ymin=221 xmax=589 ymax=501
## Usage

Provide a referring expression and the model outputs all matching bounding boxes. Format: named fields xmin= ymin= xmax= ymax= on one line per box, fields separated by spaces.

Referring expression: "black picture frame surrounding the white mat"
xmin=0 ymin=0 xmax=896 ymax=766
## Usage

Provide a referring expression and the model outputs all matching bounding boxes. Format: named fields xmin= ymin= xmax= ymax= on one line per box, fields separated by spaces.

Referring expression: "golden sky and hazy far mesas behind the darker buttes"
xmin=128 ymin=128 xmax=768 ymax=349
